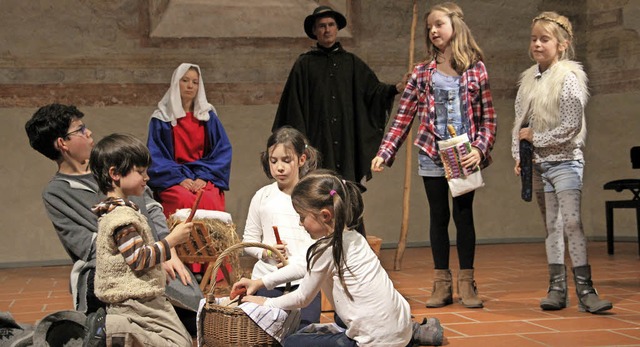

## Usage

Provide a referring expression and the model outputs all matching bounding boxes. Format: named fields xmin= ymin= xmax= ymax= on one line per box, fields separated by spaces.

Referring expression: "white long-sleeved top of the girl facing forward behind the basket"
xmin=242 ymin=182 xmax=313 ymax=289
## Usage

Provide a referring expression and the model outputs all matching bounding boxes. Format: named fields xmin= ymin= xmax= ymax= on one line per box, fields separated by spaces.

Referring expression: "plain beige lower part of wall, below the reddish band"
xmin=0 ymin=89 xmax=640 ymax=266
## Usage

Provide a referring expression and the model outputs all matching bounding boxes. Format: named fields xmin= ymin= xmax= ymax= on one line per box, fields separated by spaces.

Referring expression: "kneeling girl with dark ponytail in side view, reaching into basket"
xmin=232 ymin=170 xmax=443 ymax=347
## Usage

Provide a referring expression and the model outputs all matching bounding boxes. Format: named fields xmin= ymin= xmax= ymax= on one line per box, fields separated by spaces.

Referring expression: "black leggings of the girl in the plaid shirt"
xmin=422 ymin=177 xmax=476 ymax=270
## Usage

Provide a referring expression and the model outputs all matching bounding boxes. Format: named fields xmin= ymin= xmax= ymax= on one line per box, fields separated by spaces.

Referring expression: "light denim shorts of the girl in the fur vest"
xmin=533 ymin=159 xmax=584 ymax=193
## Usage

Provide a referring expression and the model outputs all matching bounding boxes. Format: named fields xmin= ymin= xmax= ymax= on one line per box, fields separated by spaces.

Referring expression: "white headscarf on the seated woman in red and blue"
xmin=151 ymin=63 xmax=215 ymax=126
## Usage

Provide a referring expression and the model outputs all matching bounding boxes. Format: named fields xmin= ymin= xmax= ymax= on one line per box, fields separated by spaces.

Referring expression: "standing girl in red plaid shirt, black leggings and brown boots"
xmin=371 ymin=3 xmax=496 ymax=308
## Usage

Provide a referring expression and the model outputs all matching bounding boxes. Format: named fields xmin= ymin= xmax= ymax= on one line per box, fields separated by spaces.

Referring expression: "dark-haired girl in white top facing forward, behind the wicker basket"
xmin=242 ymin=127 xmax=321 ymax=327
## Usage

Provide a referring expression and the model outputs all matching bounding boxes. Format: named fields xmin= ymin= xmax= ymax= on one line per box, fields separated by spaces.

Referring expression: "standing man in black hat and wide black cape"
xmin=272 ymin=6 xmax=406 ymax=188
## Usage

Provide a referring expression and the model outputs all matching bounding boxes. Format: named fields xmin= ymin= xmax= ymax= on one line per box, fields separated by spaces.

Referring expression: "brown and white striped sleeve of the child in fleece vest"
xmin=113 ymin=224 xmax=171 ymax=271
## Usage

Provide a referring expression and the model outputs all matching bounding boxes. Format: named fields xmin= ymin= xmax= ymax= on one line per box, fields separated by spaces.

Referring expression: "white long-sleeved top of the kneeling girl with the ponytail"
xmin=263 ymin=230 xmax=412 ymax=347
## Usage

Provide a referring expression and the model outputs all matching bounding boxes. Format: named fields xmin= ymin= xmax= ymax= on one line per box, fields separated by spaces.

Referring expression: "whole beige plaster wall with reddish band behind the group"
xmin=0 ymin=0 xmax=640 ymax=267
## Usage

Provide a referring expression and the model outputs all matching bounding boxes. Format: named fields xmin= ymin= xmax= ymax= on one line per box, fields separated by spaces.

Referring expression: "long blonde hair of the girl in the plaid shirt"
xmin=424 ymin=2 xmax=484 ymax=74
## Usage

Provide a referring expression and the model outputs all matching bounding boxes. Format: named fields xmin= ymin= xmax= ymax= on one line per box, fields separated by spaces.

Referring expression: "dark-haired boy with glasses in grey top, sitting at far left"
xmin=25 ymin=104 xmax=203 ymax=335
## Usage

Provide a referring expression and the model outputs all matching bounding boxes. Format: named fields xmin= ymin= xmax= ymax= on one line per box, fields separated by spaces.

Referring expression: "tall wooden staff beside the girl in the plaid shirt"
xmin=393 ymin=0 xmax=418 ymax=271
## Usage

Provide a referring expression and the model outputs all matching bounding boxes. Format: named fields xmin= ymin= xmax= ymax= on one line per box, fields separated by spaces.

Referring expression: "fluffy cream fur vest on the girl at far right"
xmin=513 ymin=60 xmax=589 ymax=145
